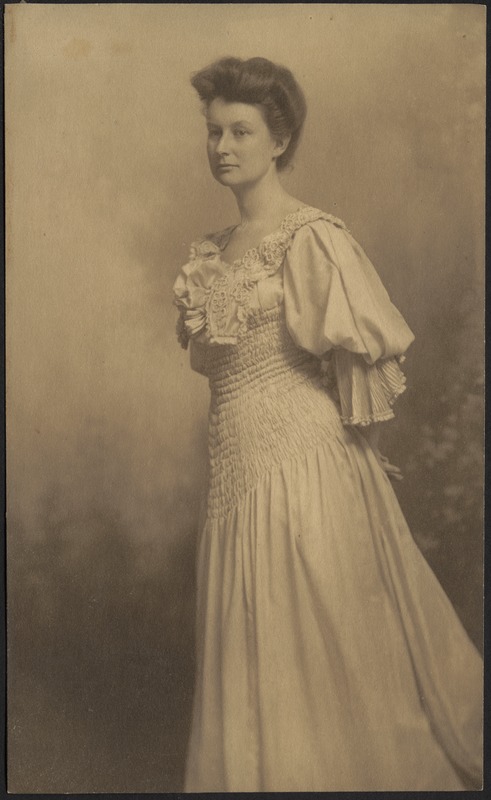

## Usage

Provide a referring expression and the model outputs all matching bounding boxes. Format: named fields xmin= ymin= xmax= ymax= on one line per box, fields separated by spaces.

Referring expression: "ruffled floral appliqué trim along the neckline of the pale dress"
xmin=174 ymin=206 xmax=346 ymax=349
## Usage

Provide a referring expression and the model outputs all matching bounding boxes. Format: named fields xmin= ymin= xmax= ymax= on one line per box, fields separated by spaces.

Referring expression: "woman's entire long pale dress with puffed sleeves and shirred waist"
xmin=174 ymin=207 xmax=482 ymax=792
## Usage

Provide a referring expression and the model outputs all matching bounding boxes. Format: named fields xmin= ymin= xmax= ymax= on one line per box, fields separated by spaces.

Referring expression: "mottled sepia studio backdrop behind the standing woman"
xmin=5 ymin=4 xmax=485 ymax=792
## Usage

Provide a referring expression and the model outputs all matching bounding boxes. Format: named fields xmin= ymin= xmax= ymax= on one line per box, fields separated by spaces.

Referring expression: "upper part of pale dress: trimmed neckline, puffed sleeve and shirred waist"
xmin=174 ymin=207 xmax=413 ymax=476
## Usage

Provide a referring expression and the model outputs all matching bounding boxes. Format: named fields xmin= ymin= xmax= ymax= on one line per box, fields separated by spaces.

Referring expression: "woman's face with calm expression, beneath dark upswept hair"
xmin=206 ymin=97 xmax=288 ymax=187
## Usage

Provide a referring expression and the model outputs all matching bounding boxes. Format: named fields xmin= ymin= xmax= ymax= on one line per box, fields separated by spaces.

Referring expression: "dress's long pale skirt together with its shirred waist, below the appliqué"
xmin=185 ymin=306 xmax=482 ymax=792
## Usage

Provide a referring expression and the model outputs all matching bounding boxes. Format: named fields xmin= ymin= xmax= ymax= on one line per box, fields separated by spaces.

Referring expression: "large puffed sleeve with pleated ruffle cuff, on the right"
xmin=283 ymin=212 xmax=414 ymax=425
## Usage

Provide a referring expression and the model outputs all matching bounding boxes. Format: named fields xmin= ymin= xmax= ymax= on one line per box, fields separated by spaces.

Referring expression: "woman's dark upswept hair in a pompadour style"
xmin=191 ymin=57 xmax=307 ymax=170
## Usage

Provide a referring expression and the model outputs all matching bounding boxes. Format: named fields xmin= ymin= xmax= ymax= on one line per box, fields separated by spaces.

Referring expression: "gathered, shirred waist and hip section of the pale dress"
xmin=203 ymin=307 xmax=346 ymax=517
